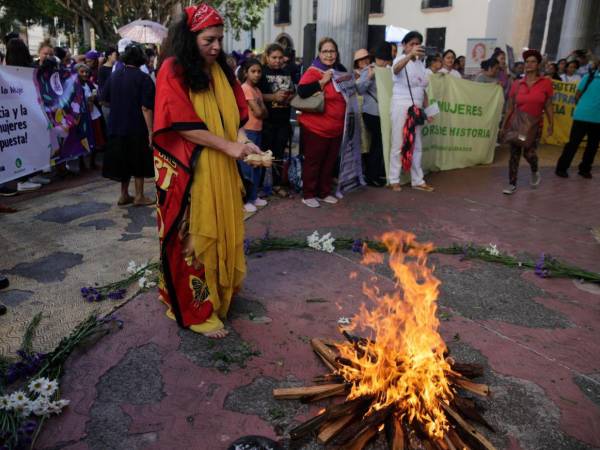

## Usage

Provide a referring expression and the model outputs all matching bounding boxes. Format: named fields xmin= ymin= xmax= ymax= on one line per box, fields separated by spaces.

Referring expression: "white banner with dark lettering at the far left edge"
xmin=0 ymin=66 xmax=51 ymax=183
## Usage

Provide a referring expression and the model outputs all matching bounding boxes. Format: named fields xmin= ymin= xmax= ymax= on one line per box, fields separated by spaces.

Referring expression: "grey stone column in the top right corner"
xmin=557 ymin=0 xmax=597 ymax=58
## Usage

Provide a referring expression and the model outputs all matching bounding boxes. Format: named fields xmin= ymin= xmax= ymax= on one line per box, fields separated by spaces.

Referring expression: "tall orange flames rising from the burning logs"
xmin=338 ymin=231 xmax=454 ymax=439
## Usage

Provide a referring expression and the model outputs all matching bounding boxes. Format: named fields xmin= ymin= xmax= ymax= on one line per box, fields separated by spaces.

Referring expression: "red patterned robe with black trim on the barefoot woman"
xmin=153 ymin=58 xmax=248 ymax=327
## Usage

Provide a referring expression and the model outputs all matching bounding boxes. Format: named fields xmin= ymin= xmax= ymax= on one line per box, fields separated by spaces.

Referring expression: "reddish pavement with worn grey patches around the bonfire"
xmin=0 ymin=148 xmax=600 ymax=450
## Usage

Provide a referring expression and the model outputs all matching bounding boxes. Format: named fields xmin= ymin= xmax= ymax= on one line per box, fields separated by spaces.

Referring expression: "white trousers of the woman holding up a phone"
xmin=388 ymin=98 xmax=425 ymax=186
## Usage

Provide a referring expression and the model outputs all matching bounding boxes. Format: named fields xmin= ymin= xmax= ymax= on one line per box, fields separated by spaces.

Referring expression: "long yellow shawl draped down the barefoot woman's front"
xmin=190 ymin=63 xmax=246 ymax=318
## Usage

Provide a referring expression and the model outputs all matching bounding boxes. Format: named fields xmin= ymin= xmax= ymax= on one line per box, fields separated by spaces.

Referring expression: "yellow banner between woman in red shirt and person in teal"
xmin=542 ymin=80 xmax=577 ymax=145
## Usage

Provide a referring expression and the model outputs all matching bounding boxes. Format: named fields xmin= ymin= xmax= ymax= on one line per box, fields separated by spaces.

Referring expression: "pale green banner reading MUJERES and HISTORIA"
xmin=376 ymin=69 xmax=504 ymax=177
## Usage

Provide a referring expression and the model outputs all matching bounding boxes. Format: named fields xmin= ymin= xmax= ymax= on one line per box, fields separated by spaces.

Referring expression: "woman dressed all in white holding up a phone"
xmin=388 ymin=31 xmax=433 ymax=192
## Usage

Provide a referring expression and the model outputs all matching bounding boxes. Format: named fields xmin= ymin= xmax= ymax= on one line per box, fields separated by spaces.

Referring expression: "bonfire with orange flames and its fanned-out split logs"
xmin=273 ymin=231 xmax=494 ymax=450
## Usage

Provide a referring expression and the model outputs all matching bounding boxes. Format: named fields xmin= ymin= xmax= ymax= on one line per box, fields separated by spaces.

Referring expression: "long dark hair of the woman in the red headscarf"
xmin=159 ymin=13 xmax=235 ymax=92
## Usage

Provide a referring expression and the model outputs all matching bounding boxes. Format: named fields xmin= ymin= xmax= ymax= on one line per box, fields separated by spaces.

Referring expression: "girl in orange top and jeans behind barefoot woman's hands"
xmin=240 ymin=59 xmax=267 ymax=212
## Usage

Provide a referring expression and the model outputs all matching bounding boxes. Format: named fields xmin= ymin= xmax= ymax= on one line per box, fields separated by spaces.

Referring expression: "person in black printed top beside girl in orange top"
xmin=258 ymin=44 xmax=294 ymax=197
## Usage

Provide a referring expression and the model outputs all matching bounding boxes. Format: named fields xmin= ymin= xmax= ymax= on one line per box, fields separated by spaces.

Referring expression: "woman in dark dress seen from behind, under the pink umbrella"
xmin=102 ymin=45 xmax=155 ymax=206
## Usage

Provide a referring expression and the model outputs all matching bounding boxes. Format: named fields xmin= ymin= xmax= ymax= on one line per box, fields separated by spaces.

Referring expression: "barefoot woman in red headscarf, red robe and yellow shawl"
xmin=153 ymin=4 xmax=261 ymax=338
